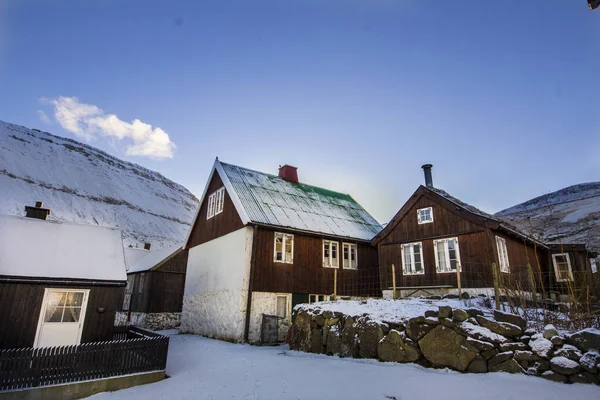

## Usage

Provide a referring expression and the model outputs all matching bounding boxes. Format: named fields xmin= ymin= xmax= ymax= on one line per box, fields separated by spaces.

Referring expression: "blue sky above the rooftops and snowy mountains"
xmin=0 ymin=0 xmax=600 ymax=222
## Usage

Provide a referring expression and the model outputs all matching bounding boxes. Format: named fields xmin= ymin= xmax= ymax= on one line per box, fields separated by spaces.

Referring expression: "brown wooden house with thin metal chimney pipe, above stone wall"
xmin=371 ymin=165 xmax=590 ymax=295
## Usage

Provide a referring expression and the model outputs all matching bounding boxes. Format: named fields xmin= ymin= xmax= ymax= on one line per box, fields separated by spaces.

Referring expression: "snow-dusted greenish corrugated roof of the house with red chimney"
xmin=215 ymin=160 xmax=382 ymax=240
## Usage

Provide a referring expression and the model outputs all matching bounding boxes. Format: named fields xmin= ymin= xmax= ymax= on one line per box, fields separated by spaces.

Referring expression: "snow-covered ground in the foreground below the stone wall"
xmin=92 ymin=335 xmax=600 ymax=400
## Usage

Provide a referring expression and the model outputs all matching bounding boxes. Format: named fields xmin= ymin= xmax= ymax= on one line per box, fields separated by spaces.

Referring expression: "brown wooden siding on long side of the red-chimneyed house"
xmin=252 ymin=227 xmax=381 ymax=296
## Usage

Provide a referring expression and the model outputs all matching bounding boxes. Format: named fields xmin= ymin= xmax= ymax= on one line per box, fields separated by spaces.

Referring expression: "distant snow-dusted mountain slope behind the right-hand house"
xmin=496 ymin=182 xmax=600 ymax=251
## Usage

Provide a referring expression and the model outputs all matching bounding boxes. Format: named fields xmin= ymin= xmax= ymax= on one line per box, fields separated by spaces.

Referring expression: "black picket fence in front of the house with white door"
xmin=0 ymin=327 xmax=169 ymax=391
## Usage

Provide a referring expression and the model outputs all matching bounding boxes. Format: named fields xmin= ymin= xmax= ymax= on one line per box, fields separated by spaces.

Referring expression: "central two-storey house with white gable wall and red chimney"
xmin=181 ymin=159 xmax=381 ymax=342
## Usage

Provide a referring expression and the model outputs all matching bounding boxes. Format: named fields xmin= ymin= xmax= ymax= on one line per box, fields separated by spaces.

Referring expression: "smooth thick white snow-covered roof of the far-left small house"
xmin=0 ymin=215 xmax=127 ymax=281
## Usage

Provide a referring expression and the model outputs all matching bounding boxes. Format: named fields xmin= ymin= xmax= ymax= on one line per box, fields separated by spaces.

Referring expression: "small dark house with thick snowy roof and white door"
xmin=0 ymin=208 xmax=126 ymax=349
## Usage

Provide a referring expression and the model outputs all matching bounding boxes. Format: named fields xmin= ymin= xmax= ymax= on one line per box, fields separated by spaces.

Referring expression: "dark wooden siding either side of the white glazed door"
xmin=0 ymin=283 xmax=124 ymax=349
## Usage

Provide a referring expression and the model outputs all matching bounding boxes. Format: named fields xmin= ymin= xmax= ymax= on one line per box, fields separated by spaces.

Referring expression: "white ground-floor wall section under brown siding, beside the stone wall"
xmin=248 ymin=292 xmax=292 ymax=343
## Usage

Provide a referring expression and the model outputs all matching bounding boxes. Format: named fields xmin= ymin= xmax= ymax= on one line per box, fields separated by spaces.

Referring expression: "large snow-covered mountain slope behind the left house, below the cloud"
xmin=0 ymin=121 xmax=198 ymax=247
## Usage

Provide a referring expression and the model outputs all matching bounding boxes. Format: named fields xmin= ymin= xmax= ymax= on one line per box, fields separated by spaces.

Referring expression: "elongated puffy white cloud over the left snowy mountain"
xmin=50 ymin=96 xmax=176 ymax=158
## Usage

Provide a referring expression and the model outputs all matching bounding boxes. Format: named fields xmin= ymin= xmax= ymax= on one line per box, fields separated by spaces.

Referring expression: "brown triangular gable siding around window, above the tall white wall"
xmin=185 ymin=171 xmax=244 ymax=249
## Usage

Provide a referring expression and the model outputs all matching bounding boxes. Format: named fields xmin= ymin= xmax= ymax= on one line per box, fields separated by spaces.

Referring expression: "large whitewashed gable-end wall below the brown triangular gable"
xmin=180 ymin=227 xmax=253 ymax=342
